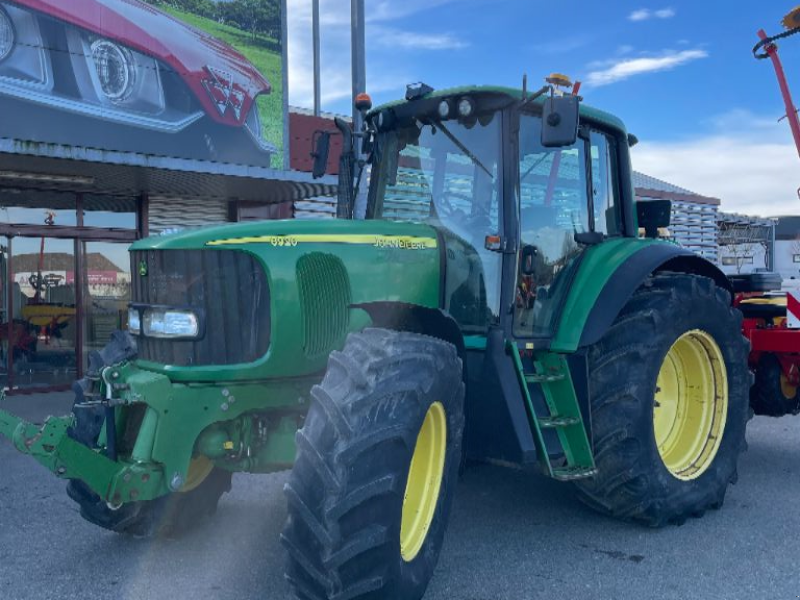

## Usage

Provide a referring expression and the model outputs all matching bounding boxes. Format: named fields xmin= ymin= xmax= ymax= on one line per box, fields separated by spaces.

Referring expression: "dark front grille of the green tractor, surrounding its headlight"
xmin=131 ymin=250 xmax=270 ymax=367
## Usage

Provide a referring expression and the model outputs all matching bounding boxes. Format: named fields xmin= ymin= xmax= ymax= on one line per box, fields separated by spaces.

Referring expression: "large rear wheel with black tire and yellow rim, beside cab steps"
xmin=577 ymin=274 xmax=751 ymax=527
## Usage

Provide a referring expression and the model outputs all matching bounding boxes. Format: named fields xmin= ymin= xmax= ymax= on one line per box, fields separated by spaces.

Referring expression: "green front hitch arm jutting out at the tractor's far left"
xmin=0 ymin=409 xmax=130 ymax=502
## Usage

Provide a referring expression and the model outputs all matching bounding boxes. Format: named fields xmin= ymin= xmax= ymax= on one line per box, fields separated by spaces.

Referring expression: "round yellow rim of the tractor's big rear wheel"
xmin=653 ymin=329 xmax=728 ymax=480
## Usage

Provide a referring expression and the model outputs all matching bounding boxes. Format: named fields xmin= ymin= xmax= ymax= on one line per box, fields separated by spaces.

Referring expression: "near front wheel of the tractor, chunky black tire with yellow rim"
xmin=282 ymin=329 xmax=464 ymax=600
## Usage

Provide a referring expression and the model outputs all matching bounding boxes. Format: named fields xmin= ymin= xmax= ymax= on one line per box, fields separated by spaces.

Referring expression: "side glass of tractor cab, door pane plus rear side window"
xmin=513 ymin=115 xmax=621 ymax=339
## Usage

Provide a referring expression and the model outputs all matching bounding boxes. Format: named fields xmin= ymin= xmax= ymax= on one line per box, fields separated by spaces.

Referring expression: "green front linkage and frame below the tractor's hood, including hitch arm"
xmin=0 ymin=362 xmax=315 ymax=506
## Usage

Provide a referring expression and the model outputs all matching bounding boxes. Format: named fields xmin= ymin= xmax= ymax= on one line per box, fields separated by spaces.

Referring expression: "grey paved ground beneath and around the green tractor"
xmin=0 ymin=395 xmax=800 ymax=600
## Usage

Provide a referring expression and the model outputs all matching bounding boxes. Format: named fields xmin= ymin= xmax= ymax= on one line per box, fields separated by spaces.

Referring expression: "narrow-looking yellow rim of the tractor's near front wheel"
xmin=400 ymin=402 xmax=447 ymax=562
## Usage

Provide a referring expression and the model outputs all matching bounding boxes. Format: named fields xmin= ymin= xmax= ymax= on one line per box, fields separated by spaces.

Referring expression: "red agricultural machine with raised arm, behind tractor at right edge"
xmin=748 ymin=6 xmax=800 ymax=417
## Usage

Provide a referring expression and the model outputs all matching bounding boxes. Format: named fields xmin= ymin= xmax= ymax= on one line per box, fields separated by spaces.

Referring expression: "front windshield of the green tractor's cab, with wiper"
xmin=367 ymin=112 xmax=502 ymax=322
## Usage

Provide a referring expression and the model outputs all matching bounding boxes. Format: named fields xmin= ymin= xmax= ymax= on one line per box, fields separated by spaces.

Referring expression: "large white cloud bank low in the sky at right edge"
xmin=631 ymin=110 xmax=800 ymax=216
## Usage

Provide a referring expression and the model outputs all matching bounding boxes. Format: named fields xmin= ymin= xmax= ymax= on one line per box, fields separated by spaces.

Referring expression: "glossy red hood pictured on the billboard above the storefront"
xmin=15 ymin=0 xmax=270 ymax=126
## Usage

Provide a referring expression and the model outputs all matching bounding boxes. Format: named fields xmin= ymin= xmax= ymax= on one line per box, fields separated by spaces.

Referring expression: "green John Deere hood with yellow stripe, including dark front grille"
xmin=131 ymin=219 xmax=445 ymax=382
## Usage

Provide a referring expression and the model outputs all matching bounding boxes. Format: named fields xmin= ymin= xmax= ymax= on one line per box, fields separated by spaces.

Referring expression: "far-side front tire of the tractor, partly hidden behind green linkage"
xmin=67 ymin=331 xmax=232 ymax=537
